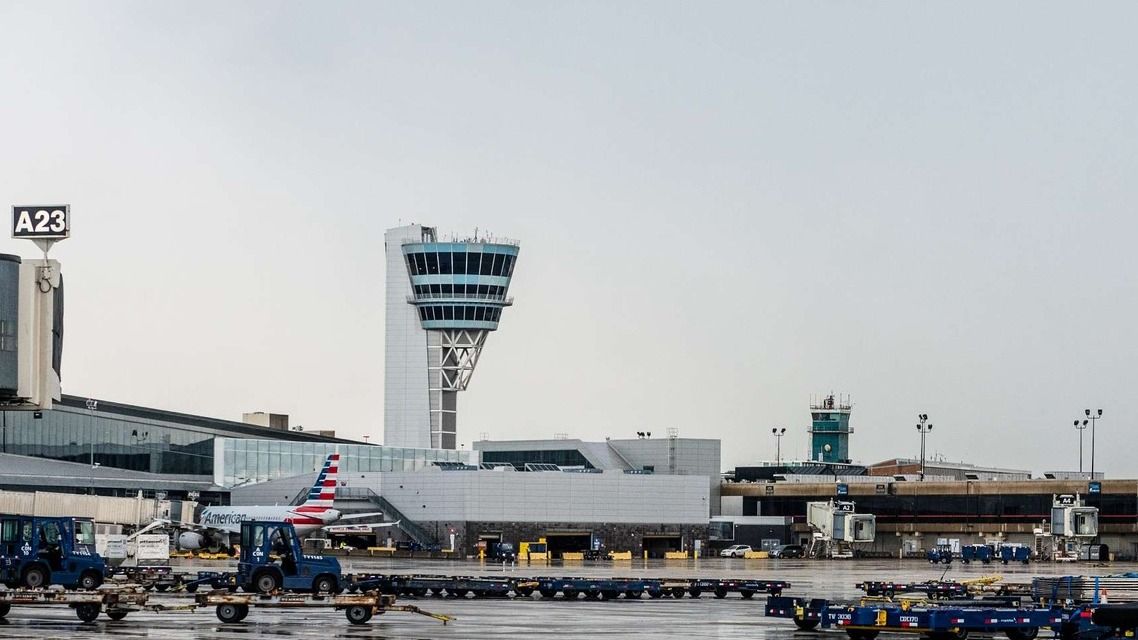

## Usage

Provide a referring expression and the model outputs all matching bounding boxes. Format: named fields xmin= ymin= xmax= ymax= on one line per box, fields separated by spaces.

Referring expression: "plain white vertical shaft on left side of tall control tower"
xmin=384 ymin=224 xmax=430 ymax=449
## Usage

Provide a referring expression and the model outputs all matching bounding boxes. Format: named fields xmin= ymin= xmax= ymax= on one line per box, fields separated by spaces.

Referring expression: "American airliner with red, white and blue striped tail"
xmin=168 ymin=453 xmax=399 ymax=550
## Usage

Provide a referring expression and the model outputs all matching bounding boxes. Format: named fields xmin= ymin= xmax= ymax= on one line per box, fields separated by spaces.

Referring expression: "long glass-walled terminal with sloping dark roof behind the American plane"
xmin=0 ymin=395 xmax=477 ymax=504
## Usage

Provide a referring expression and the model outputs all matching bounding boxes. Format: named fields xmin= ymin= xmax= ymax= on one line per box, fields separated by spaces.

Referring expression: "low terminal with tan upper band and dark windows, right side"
xmin=712 ymin=473 xmax=1138 ymax=559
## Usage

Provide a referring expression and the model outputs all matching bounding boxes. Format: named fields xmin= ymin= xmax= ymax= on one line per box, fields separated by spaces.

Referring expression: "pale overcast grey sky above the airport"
xmin=0 ymin=1 xmax=1138 ymax=477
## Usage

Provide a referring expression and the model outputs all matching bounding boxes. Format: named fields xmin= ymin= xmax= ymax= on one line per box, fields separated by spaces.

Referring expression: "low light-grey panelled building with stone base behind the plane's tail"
xmin=232 ymin=446 xmax=710 ymax=557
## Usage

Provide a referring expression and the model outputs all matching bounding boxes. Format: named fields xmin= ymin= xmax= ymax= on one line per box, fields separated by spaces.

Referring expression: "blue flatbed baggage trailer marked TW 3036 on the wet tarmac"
xmin=766 ymin=597 xmax=1065 ymax=640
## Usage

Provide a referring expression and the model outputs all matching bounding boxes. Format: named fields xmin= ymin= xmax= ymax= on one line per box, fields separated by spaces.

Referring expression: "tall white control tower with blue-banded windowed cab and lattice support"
xmin=384 ymin=224 xmax=518 ymax=449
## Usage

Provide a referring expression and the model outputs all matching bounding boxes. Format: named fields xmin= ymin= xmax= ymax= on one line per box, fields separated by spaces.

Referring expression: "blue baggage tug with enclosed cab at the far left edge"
xmin=0 ymin=514 xmax=107 ymax=590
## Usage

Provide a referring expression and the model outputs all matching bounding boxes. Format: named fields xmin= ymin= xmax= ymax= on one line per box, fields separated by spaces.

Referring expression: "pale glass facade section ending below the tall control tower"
xmin=214 ymin=437 xmax=478 ymax=486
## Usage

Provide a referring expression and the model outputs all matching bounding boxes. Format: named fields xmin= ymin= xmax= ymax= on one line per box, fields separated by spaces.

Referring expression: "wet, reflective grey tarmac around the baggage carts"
xmin=0 ymin=558 xmax=1138 ymax=640
